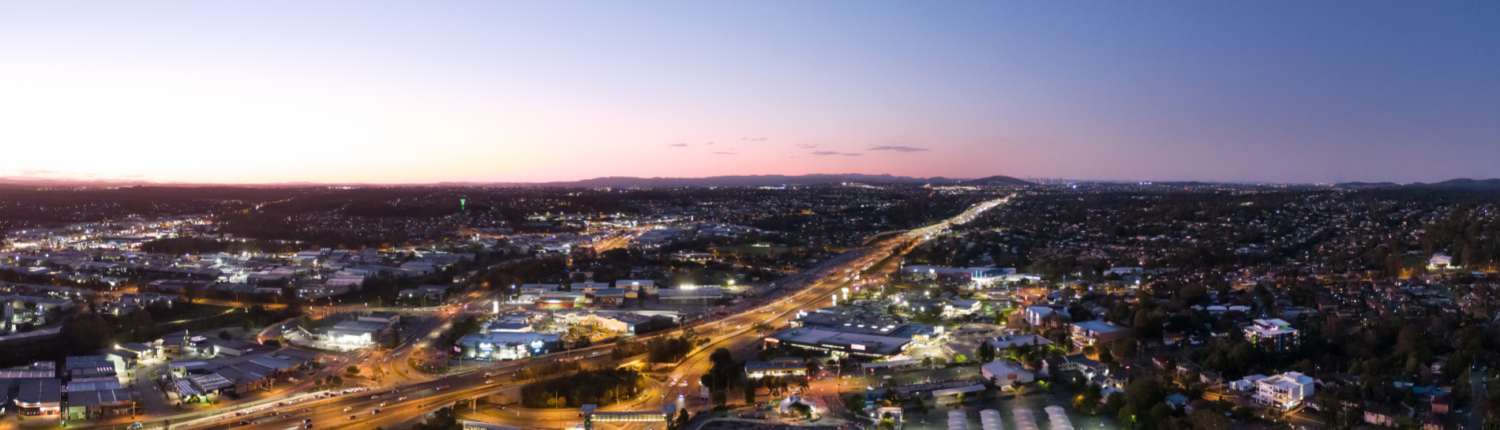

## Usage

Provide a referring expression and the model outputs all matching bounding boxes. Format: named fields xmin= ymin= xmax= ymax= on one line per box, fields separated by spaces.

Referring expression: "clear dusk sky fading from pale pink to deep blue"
xmin=0 ymin=0 xmax=1500 ymax=183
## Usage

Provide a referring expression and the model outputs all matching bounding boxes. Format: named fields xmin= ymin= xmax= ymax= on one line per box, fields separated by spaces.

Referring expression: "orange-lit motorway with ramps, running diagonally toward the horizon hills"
xmin=114 ymin=198 xmax=1008 ymax=430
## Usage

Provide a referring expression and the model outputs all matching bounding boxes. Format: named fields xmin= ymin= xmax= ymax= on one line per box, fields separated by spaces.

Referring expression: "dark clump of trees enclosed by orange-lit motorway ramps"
xmin=521 ymin=369 xmax=645 ymax=408
